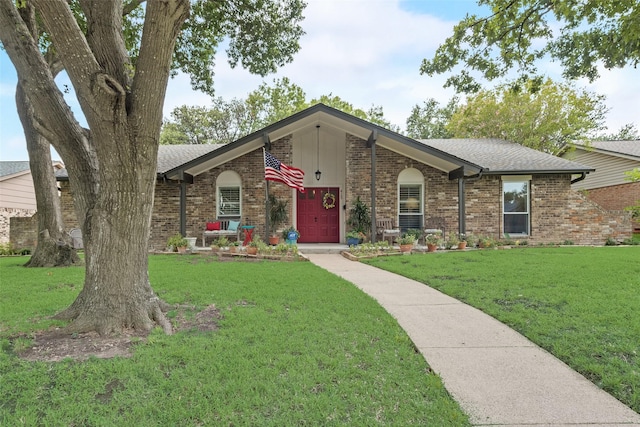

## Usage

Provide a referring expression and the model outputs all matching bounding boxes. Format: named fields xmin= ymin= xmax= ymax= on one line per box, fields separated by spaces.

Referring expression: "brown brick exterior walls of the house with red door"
xmin=52 ymin=135 xmax=631 ymax=250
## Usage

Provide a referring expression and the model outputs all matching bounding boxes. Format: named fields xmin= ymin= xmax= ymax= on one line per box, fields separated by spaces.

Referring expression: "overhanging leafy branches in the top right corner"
xmin=420 ymin=0 xmax=640 ymax=92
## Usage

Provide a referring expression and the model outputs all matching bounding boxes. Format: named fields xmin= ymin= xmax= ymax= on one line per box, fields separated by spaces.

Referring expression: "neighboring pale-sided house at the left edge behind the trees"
xmin=0 ymin=161 xmax=64 ymax=243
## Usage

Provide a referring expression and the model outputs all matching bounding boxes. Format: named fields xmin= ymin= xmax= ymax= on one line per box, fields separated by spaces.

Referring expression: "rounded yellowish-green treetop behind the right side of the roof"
xmin=447 ymin=80 xmax=606 ymax=154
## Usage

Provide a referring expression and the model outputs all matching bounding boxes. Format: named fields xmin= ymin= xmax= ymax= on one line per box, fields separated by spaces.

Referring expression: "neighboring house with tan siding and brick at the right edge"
xmin=563 ymin=140 xmax=640 ymax=231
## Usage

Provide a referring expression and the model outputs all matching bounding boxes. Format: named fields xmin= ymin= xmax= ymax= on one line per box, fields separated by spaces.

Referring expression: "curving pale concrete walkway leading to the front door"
xmin=306 ymin=254 xmax=640 ymax=426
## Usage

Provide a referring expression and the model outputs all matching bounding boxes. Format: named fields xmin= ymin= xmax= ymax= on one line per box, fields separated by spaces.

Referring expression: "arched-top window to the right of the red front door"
xmin=398 ymin=168 xmax=424 ymax=231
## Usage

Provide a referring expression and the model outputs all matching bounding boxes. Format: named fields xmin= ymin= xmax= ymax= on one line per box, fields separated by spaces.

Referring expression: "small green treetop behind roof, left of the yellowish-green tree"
xmin=407 ymin=96 xmax=459 ymax=139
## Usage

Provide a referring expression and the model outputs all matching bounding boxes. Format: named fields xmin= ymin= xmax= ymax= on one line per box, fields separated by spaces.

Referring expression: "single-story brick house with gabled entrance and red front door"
xmin=61 ymin=104 xmax=631 ymax=249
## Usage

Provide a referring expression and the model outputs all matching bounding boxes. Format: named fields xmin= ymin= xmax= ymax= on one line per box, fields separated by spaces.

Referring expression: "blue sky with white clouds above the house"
xmin=0 ymin=0 xmax=640 ymax=160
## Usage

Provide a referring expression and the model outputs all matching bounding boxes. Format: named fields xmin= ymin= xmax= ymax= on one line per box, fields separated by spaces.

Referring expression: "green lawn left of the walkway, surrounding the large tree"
xmin=0 ymin=256 xmax=469 ymax=426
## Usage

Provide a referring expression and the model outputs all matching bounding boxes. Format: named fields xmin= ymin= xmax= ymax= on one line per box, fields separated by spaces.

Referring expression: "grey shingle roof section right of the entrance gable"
xmin=420 ymin=139 xmax=593 ymax=173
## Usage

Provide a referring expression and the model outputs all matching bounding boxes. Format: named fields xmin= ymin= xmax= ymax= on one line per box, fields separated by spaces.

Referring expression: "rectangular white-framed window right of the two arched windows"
xmin=502 ymin=177 xmax=529 ymax=235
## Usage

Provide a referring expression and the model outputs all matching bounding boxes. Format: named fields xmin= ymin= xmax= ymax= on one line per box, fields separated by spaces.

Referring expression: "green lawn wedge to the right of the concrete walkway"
xmin=366 ymin=246 xmax=640 ymax=413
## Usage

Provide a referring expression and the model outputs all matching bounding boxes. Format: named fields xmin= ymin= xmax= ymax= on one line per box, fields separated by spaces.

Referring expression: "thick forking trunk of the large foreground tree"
xmin=0 ymin=0 xmax=190 ymax=335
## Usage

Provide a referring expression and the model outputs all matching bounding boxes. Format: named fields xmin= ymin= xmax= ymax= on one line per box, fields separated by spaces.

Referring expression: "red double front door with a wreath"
xmin=297 ymin=187 xmax=340 ymax=243
